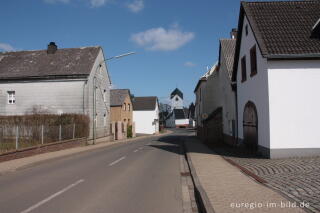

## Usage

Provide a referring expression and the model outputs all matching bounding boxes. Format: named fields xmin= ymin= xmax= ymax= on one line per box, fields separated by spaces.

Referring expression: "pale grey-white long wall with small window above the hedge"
xmin=0 ymin=80 xmax=85 ymax=115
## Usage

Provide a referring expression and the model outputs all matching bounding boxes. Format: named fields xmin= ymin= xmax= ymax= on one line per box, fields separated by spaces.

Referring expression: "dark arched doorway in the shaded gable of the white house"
xmin=243 ymin=101 xmax=258 ymax=151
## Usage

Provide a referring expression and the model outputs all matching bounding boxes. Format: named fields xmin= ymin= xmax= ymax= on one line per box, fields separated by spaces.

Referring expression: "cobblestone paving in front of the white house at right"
xmin=226 ymin=157 xmax=320 ymax=212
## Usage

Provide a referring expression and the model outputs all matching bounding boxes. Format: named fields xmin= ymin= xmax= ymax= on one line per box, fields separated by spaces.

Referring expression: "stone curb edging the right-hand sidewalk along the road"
xmin=183 ymin=140 xmax=215 ymax=213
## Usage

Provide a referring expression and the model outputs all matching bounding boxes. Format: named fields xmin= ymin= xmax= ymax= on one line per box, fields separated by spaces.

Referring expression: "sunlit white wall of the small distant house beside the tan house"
xmin=133 ymin=103 xmax=159 ymax=134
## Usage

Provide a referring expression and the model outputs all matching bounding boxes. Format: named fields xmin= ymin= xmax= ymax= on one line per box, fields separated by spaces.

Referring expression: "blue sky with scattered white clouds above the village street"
xmin=0 ymin=0 xmax=240 ymax=104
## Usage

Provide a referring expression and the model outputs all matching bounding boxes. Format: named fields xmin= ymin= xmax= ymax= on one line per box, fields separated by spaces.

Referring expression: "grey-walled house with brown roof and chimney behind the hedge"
xmin=0 ymin=42 xmax=111 ymax=141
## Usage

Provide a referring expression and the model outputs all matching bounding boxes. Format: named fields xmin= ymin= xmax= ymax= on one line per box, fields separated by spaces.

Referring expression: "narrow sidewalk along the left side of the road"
xmin=0 ymin=131 xmax=171 ymax=175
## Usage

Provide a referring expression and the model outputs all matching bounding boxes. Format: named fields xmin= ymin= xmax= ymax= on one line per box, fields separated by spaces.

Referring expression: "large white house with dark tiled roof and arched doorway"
xmin=232 ymin=0 xmax=320 ymax=158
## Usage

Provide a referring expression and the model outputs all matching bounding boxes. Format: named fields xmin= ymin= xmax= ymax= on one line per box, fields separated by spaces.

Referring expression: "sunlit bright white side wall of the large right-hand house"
xmin=268 ymin=60 xmax=320 ymax=149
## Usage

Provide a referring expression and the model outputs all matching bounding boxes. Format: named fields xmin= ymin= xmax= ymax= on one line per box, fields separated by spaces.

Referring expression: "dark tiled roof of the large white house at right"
xmin=232 ymin=0 xmax=320 ymax=81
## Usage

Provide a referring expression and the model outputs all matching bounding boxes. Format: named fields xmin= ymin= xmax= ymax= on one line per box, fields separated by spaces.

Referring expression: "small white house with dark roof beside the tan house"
xmin=132 ymin=96 xmax=159 ymax=134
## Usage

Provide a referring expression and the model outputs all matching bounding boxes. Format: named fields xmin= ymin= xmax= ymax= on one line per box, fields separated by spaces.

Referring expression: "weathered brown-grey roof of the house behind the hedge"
xmin=0 ymin=47 xmax=101 ymax=80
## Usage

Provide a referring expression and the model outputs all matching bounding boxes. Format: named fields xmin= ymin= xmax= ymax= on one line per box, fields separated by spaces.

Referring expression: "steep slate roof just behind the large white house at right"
xmin=219 ymin=39 xmax=236 ymax=79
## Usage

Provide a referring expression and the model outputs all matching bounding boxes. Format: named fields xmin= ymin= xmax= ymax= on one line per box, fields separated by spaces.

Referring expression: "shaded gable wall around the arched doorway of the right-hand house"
xmin=237 ymin=17 xmax=270 ymax=148
